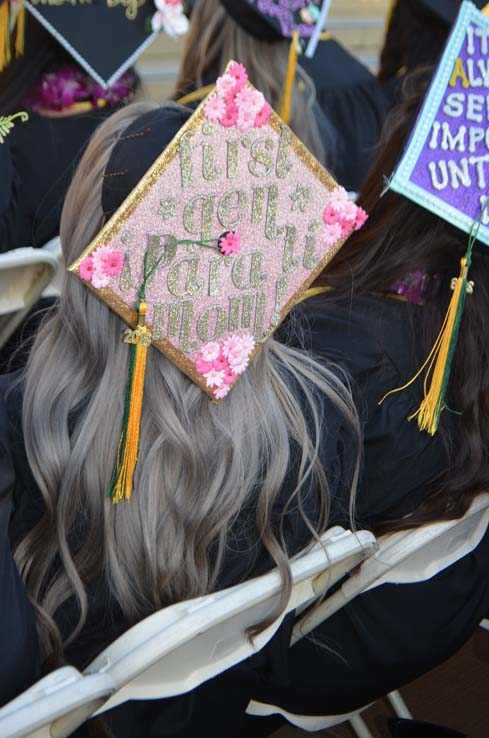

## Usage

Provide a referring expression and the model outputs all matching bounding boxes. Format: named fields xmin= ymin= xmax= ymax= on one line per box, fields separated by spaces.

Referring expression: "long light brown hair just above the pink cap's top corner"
xmin=173 ymin=0 xmax=328 ymax=161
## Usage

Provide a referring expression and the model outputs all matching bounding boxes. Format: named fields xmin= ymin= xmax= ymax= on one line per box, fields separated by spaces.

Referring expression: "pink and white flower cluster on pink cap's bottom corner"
xmin=195 ymin=332 xmax=256 ymax=400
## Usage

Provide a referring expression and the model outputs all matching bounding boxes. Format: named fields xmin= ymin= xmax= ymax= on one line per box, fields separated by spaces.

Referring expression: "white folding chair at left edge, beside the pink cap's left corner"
xmin=0 ymin=240 xmax=60 ymax=348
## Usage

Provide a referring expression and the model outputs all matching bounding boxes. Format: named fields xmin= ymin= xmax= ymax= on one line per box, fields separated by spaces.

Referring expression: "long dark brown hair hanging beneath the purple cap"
xmin=319 ymin=69 xmax=489 ymax=527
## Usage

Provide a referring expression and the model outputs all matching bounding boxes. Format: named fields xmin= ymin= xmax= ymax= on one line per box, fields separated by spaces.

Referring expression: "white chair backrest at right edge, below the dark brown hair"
xmin=291 ymin=494 xmax=489 ymax=644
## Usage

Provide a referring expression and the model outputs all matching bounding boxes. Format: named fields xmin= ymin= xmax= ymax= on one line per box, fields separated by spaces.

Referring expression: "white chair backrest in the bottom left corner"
xmin=0 ymin=666 xmax=113 ymax=738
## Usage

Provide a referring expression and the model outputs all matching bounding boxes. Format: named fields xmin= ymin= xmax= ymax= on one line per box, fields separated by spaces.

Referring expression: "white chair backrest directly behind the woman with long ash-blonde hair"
xmin=85 ymin=528 xmax=376 ymax=712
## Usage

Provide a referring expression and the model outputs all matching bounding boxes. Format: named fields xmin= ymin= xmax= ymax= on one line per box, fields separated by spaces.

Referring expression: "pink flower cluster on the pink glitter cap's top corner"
xmin=204 ymin=62 xmax=272 ymax=131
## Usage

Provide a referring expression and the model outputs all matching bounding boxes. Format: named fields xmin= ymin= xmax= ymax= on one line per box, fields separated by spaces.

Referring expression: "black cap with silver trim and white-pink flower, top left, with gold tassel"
xmin=0 ymin=0 xmax=188 ymax=87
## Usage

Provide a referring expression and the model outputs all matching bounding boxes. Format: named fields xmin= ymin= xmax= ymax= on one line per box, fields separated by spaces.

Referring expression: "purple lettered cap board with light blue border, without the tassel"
xmin=390 ymin=2 xmax=489 ymax=245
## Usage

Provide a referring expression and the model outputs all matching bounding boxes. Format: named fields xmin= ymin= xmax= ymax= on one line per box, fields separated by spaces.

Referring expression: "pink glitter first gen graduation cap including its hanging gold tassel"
xmin=69 ymin=62 xmax=366 ymax=502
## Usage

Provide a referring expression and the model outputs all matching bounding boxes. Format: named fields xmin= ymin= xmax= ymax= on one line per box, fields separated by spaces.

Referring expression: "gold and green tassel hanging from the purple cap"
xmin=379 ymin=256 xmax=473 ymax=436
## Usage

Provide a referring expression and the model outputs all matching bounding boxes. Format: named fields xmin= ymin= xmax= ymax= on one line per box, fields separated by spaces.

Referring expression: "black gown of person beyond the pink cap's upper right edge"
xmin=300 ymin=39 xmax=389 ymax=192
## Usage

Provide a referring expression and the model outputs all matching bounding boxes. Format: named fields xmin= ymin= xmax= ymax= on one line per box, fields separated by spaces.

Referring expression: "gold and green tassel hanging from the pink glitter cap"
xmin=108 ymin=300 xmax=152 ymax=504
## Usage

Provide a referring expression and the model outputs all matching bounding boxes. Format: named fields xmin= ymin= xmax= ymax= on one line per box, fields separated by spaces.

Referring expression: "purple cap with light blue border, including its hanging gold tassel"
xmin=384 ymin=2 xmax=489 ymax=435
